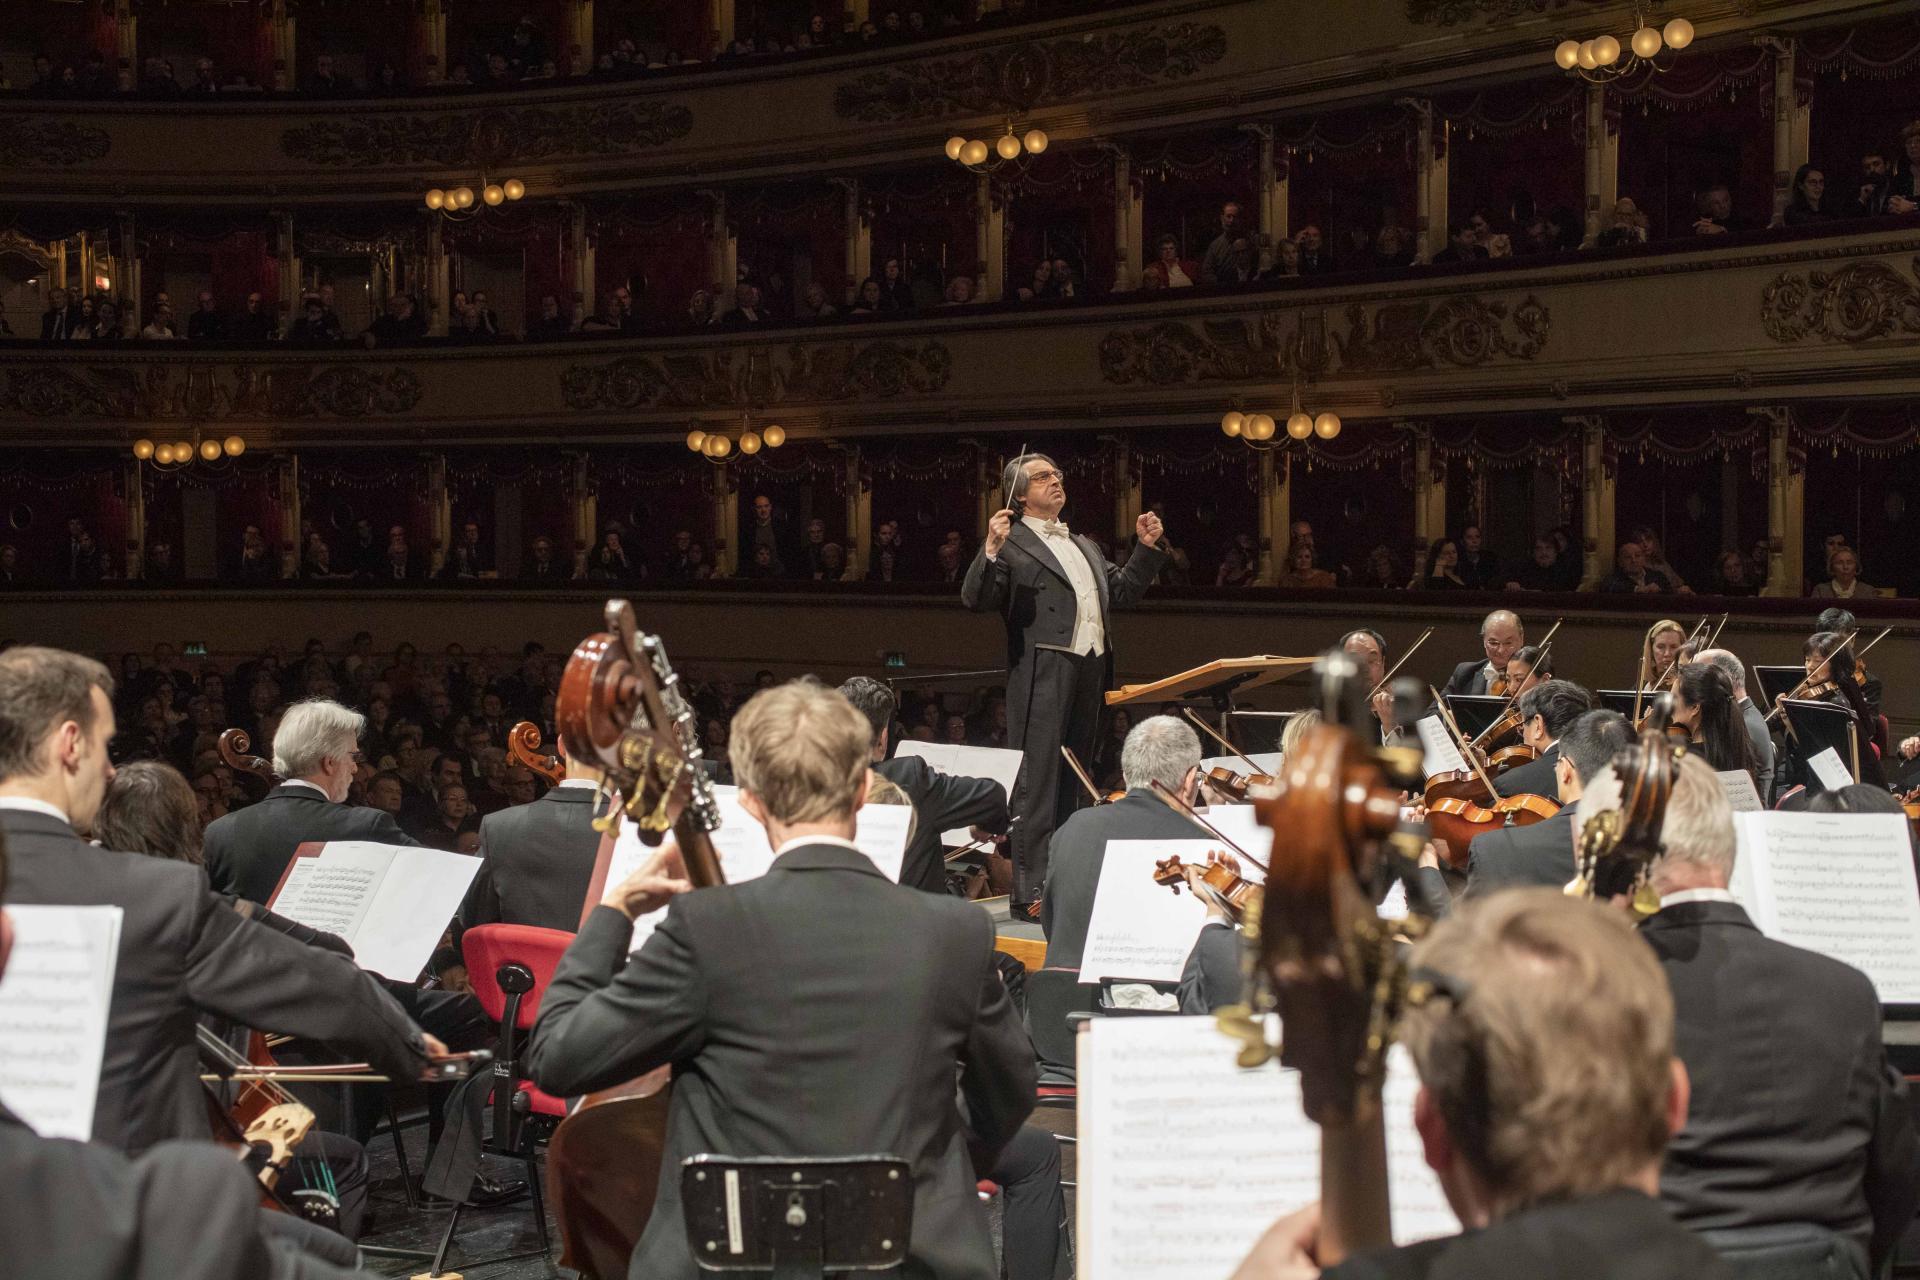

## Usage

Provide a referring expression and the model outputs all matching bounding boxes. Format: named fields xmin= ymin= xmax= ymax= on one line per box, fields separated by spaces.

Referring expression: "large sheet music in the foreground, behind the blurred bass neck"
xmin=1077 ymin=1017 xmax=1459 ymax=1280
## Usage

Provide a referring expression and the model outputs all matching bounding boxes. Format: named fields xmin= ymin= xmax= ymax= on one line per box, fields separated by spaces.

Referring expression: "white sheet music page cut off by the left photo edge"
xmin=0 ymin=906 xmax=125 ymax=1142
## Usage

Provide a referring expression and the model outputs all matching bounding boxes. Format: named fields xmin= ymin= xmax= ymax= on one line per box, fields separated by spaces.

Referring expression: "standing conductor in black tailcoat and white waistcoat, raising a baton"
xmin=960 ymin=453 xmax=1167 ymax=913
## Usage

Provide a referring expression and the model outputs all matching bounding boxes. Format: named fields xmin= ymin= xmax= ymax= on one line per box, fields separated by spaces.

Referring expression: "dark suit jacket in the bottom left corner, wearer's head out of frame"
xmin=0 ymin=1105 xmax=363 ymax=1280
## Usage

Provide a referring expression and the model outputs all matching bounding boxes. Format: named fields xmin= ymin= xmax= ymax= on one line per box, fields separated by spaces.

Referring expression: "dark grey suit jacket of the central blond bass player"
xmin=530 ymin=844 xmax=1035 ymax=1280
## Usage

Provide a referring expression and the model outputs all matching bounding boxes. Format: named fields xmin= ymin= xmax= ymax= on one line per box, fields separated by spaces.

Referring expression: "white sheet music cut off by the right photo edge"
xmin=1734 ymin=812 xmax=1920 ymax=1004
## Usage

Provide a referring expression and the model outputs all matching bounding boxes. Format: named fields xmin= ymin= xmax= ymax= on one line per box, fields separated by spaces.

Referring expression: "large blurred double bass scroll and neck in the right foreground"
xmin=1221 ymin=652 xmax=1425 ymax=1267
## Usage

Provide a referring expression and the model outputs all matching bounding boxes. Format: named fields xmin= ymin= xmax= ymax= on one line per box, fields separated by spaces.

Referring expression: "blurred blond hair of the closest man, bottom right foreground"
xmin=1402 ymin=889 xmax=1674 ymax=1217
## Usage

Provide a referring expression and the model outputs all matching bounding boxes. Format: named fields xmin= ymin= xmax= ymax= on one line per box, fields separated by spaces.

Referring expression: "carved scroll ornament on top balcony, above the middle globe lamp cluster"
xmin=833 ymin=23 xmax=1227 ymax=123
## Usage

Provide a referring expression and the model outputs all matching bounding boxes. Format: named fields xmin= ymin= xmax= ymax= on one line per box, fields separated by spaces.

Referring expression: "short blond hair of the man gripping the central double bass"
xmin=728 ymin=679 xmax=874 ymax=825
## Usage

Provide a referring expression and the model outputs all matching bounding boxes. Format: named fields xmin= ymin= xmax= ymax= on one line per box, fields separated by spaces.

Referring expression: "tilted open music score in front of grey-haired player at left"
xmin=267 ymin=841 xmax=480 ymax=983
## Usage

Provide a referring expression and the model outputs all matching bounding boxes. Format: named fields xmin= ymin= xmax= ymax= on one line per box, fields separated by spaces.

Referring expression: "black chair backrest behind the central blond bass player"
xmin=680 ymin=1155 xmax=914 ymax=1280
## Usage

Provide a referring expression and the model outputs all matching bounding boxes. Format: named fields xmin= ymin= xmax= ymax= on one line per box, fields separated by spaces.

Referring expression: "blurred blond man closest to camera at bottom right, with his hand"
xmin=1233 ymin=889 xmax=1732 ymax=1280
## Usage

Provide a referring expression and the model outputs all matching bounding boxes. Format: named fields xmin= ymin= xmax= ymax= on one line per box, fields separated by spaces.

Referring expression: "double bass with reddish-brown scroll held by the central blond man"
xmin=547 ymin=601 xmax=726 ymax=1280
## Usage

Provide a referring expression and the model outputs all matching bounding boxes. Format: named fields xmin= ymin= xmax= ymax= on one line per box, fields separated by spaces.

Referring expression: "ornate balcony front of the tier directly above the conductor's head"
xmin=0 ymin=225 xmax=1920 ymax=447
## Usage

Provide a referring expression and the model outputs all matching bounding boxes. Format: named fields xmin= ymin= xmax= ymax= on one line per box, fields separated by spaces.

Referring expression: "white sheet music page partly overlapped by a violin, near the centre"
xmin=1081 ymin=841 xmax=1228 ymax=983
